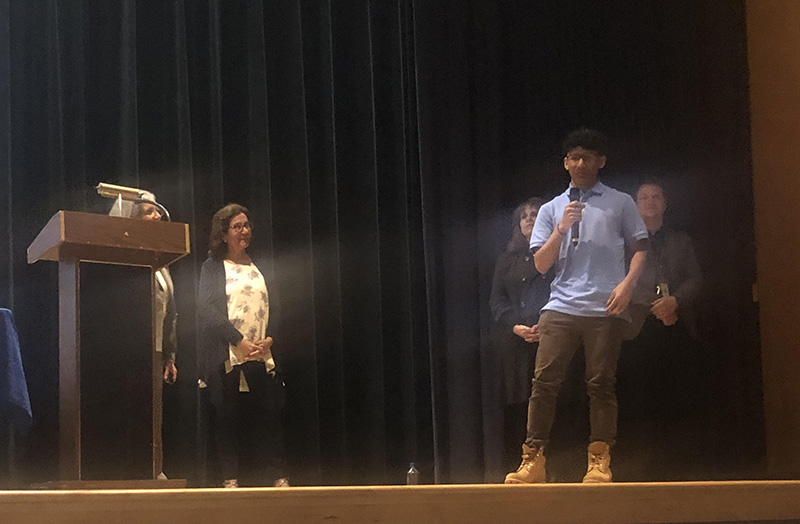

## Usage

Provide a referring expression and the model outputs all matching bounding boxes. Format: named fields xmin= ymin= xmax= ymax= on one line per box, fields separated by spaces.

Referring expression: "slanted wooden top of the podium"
xmin=28 ymin=211 xmax=190 ymax=269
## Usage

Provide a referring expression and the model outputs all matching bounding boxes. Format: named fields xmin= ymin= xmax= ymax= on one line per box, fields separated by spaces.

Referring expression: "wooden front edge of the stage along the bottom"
xmin=0 ymin=481 xmax=800 ymax=524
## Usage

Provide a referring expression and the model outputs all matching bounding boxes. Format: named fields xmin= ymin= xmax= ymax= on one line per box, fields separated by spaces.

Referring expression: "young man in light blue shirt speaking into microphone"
xmin=506 ymin=129 xmax=648 ymax=484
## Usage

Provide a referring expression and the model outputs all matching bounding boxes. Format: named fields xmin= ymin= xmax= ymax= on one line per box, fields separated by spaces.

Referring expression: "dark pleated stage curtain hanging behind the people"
xmin=0 ymin=0 xmax=764 ymax=485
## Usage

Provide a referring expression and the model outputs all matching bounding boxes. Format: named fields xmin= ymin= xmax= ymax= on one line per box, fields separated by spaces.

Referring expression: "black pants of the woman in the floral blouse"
xmin=216 ymin=362 xmax=285 ymax=486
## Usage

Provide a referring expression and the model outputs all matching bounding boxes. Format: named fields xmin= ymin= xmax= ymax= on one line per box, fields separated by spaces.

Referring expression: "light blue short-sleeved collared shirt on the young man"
xmin=531 ymin=182 xmax=647 ymax=319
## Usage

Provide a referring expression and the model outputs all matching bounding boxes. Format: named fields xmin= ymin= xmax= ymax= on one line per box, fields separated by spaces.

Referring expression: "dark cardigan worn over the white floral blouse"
xmin=197 ymin=258 xmax=278 ymax=386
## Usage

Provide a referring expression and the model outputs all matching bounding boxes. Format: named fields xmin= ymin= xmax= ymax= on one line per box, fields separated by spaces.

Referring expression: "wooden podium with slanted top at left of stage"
xmin=28 ymin=211 xmax=189 ymax=481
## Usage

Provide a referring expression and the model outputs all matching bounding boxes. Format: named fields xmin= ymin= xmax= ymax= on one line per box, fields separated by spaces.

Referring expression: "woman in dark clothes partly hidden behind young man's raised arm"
xmin=489 ymin=198 xmax=553 ymax=469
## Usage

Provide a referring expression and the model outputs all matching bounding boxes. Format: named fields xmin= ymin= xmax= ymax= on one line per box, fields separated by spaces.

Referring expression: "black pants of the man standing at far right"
xmin=615 ymin=315 xmax=711 ymax=481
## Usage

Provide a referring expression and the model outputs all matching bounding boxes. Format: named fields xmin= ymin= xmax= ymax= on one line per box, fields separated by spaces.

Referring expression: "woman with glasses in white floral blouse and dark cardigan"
xmin=198 ymin=204 xmax=287 ymax=487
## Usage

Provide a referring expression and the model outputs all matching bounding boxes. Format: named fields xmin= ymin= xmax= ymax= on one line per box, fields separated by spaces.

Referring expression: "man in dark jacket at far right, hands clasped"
xmin=619 ymin=179 xmax=707 ymax=480
